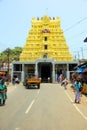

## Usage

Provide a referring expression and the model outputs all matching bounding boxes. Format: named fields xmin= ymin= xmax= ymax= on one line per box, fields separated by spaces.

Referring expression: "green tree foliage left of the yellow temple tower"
xmin=0 ymin=47 xmax=23 ymax=63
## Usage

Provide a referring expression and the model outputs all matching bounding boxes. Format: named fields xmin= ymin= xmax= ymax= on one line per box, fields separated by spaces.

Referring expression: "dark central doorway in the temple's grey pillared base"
xmin=41 ymin=65 xmax=51 ymax=82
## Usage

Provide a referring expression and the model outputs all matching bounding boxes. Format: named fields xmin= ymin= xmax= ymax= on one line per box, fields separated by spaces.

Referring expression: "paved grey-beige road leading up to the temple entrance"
xmin=0 ymin=83 xmax=87 ymax=130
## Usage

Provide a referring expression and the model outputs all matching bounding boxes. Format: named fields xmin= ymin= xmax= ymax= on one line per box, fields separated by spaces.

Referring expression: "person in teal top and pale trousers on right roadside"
xmin=74 ymin=78 xmax=82 ymax=103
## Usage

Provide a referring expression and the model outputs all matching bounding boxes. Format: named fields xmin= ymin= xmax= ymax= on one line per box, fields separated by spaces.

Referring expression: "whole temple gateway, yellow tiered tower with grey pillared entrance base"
xmin=11 ymin=16 xmax=78 ymax=83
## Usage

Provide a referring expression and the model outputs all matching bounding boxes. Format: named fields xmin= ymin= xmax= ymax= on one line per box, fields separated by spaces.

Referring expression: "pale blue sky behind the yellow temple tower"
xmin=0 ymin=0 xmax=87 ymax=59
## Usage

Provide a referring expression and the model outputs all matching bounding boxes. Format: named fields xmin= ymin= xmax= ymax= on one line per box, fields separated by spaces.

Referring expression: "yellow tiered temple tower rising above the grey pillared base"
xmin=20 ymin=16 xmax=73 ymax=62
